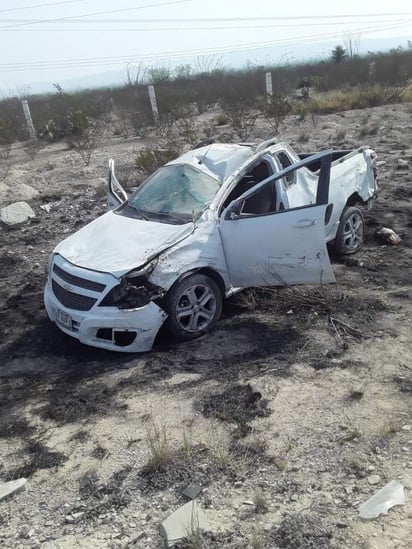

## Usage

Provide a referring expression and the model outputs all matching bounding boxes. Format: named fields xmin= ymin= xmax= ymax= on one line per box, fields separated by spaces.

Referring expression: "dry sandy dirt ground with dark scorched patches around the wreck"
xmin=0 ymin=104 xmax=412 ymax=549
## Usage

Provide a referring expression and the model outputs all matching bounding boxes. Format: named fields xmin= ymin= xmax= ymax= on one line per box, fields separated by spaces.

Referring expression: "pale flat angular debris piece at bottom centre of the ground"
xmin=161 ymin=501 xmax=210 ymax=547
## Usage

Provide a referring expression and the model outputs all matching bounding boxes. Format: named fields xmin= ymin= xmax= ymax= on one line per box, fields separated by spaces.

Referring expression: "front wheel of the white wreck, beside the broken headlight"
xmin=164 ymin=273 xmax=223 ymax=341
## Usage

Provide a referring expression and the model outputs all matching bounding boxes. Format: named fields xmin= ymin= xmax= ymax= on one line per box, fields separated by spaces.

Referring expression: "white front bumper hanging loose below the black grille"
xmin=44 ymin=281 xmax=167 ymax=353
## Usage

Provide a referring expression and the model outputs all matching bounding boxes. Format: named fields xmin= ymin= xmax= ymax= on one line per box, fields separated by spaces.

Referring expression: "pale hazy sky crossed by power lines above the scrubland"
xmin=0 ymin=0 xmax=412 ymax=93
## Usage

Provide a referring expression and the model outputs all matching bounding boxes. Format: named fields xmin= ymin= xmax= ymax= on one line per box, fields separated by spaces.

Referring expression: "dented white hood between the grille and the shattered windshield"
xmin=54 ymin=211 xmax=193 ymax=276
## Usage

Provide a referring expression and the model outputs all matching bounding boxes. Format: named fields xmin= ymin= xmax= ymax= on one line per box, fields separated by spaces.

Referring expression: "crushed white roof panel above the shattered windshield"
xmin=169 ymin=143 xmax=254 ymax=183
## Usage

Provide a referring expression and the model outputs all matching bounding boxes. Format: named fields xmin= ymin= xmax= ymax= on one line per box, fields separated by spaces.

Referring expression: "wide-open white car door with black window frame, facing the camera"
xmin=219 ymin=151 xmax=335 ymax=288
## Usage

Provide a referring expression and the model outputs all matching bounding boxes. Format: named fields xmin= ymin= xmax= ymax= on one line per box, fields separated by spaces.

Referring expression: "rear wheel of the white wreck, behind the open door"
xmin=334 ymin=206 xmax=365 ymax=255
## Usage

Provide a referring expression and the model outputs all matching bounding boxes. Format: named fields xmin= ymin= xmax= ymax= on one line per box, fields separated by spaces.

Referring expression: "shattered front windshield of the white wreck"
xmin=123 ymin=164 xmax=220 ymax=223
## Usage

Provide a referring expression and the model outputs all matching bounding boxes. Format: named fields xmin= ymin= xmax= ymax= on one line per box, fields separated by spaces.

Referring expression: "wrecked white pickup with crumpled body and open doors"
xmin=44 ymin=140 xmax=377 ymax=352
